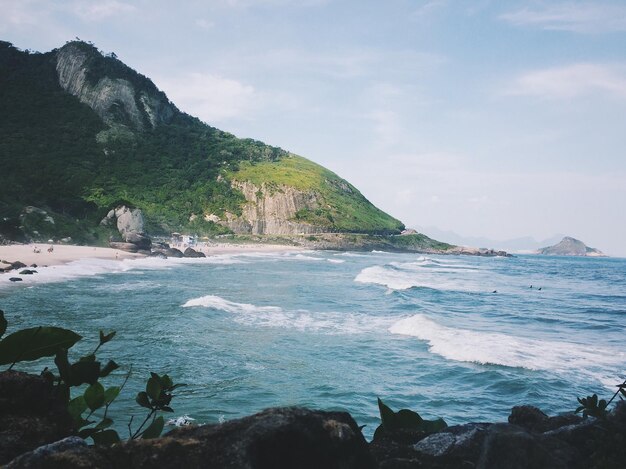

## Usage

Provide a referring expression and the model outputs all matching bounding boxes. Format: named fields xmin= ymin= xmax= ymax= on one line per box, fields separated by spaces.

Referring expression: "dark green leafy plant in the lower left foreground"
xmin=0 ymin=310 xmax=184 ymax=445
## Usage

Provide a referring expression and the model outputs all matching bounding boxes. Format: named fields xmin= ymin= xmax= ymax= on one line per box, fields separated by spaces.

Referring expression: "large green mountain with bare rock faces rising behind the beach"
xmin=0 ymin=41 xmax=404 ymax=242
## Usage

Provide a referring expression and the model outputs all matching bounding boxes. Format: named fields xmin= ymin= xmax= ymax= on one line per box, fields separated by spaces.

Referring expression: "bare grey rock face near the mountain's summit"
xmin=56 ymin=43 xmax=176 ymax=130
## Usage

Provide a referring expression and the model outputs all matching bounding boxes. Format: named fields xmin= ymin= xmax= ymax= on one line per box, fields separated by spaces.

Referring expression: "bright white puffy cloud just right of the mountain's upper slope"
xmin=154 ymin=73 xmax=257 ymax=124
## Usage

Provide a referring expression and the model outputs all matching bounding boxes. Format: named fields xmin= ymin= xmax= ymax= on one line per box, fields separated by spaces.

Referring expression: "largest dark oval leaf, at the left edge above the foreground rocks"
xmin=0 ymin=327 xmax=82 ymax=365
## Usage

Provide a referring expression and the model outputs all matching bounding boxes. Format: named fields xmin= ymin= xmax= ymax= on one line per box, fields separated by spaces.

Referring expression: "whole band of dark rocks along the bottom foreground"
xmin=0 ymin=372 xmax=626 ymax=469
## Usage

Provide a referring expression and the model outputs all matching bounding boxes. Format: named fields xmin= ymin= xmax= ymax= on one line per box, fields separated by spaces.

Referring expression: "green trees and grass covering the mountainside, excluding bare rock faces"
xmin=0 ymin=42 xmax=402 ymax=242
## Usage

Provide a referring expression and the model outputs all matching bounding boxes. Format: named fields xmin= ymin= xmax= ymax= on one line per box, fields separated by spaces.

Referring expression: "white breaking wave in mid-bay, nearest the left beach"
xmin=182 ymin=295 xmax=393 ymax=335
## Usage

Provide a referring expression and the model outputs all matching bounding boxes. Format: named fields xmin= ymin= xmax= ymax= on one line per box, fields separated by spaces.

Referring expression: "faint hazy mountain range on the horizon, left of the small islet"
xmin=415 ymin=226 xmax=564 ymax=253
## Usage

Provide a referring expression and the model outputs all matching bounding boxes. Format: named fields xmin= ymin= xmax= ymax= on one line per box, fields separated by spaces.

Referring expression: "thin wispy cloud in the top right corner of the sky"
xmin=500 ymin=2 xmax=626 ymax=33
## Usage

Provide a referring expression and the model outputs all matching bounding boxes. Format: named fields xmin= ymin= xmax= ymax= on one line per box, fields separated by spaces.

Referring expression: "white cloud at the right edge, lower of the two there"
xmin=504 ymin=63 xmax=626 ymax=99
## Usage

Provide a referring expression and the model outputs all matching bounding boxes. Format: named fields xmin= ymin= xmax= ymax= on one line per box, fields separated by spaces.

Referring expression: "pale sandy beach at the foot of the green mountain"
xmin=0 ymin=244 xmax=301 ymax=269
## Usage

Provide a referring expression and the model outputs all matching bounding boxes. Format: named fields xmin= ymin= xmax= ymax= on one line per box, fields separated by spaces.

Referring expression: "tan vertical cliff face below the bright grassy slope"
xmin=219 ymin=181 xmax=324 ymax=235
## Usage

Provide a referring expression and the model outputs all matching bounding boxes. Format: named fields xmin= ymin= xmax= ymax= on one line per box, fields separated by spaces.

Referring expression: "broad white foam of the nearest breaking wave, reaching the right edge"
xmin=389 ymin=314 xmax=626 ymax=377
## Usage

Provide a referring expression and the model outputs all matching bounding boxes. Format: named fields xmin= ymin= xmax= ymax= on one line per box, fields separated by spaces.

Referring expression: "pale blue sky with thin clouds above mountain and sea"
xmin=0 ymin=0 xmax=626 ymax=257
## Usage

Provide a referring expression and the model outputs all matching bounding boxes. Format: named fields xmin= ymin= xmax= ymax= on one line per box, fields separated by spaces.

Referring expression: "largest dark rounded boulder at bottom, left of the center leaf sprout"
xmin=8 ymin=408 xmax=376 ymax=469
